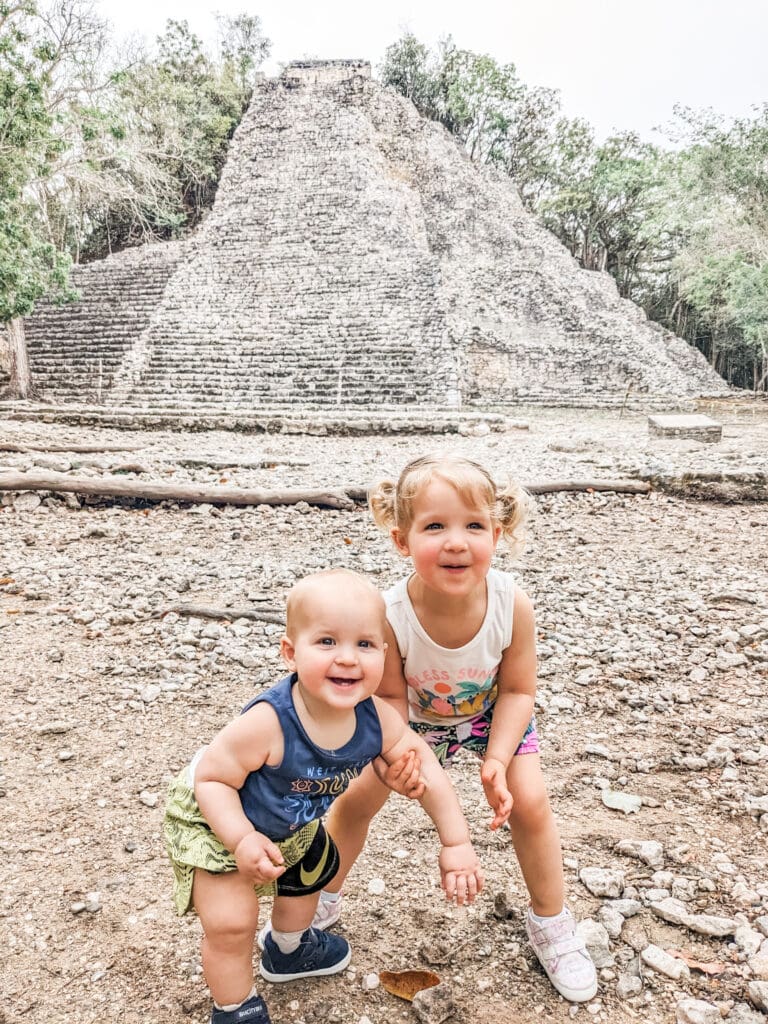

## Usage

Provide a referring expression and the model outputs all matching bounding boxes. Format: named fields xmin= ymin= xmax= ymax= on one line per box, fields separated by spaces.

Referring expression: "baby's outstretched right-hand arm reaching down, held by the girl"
xmin=374 ymin=697 xmax=483 ymax=904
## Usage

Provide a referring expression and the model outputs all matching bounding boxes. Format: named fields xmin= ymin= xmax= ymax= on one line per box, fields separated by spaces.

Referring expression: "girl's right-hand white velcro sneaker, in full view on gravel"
xmin=525 ymin=907 xmax=597 ymax=1002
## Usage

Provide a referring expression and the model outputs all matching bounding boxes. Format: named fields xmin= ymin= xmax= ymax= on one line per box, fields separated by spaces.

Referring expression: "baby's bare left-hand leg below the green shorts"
xmin=193 ymin=868 xmax=262 ymax=1007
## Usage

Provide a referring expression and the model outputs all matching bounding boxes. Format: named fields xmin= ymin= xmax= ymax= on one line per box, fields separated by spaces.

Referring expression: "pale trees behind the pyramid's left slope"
xmin=24 ymin=9 xmax=268 ymax=261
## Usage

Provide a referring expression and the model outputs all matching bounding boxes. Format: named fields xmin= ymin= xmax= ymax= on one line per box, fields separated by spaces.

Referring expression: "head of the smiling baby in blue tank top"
xmin=281 ymin=578 xmax=386 ymax=711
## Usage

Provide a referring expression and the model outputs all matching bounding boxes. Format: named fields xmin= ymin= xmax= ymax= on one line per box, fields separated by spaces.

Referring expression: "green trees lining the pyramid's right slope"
xmin=381 ymin=34 xmax=768 ymax=390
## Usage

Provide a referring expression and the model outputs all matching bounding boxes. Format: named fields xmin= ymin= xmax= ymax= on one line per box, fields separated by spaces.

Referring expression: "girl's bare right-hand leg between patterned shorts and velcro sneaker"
xmin=507 ymin=754 xmax=565 ymax=918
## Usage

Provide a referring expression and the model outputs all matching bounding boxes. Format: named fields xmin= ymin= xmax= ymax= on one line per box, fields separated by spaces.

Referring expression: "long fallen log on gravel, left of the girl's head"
xmin=0 ymin=471 xmax=354 ymax=509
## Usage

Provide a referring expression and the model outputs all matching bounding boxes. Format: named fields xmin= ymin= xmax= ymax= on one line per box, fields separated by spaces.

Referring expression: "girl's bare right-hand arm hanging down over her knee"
xmin=480 ymin=589 xmax=536 ymax=828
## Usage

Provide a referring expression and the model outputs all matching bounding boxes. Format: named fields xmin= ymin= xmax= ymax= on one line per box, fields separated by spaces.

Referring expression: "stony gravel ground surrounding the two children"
xmin=0 ymin=406 xmax=768 ymax=1024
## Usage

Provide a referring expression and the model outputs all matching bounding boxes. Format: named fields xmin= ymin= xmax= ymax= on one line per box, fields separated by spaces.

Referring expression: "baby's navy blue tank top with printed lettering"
xmin=240 ymin=673 xmax=382 ymax=840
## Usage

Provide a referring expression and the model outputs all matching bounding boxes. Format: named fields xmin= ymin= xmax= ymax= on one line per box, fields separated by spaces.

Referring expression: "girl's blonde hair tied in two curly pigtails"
xmin=368 ymin=455 xmax=532 ymax=554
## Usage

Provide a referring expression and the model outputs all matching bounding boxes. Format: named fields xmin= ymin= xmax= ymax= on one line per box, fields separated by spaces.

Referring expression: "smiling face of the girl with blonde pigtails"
xmin=392 ymin=477 xmax=501 ymax=597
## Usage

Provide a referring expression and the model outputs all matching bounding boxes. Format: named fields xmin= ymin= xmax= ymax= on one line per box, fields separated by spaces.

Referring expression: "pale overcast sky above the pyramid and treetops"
xmin=98 ymin=0 xmax=768 ymax=139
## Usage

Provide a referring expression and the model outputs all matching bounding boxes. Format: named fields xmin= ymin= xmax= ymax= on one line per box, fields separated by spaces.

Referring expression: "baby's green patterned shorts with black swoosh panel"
xmin=163 ymin=768 xmax=339 ymax=914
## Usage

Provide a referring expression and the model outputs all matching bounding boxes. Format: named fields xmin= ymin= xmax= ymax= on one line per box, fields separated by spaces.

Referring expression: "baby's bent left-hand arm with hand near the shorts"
xmin=195 ymin=703 xmax=285 ymax=885
